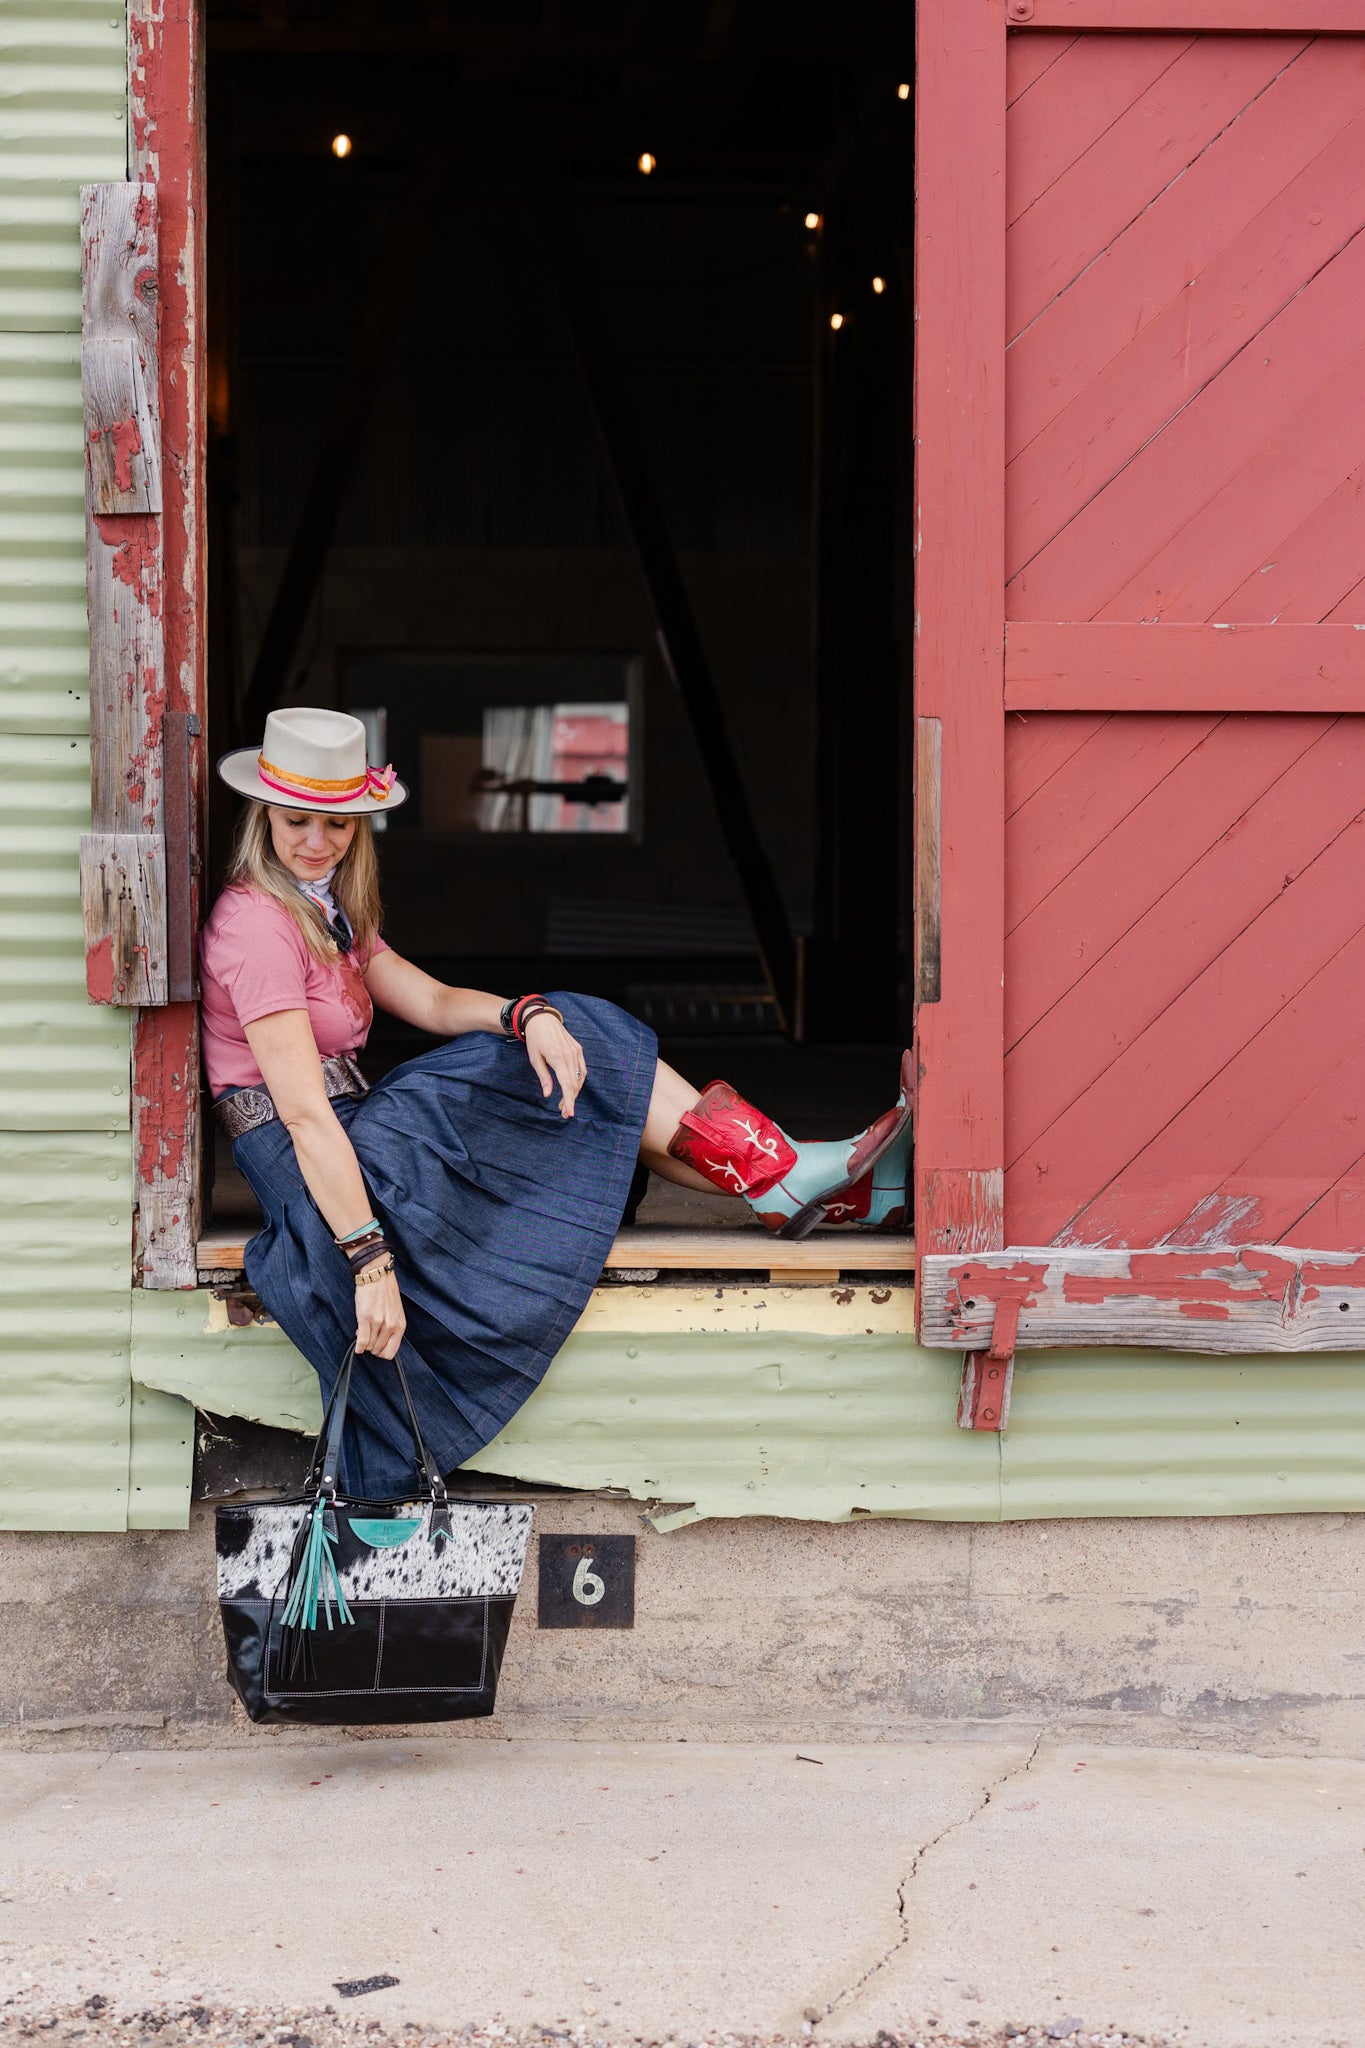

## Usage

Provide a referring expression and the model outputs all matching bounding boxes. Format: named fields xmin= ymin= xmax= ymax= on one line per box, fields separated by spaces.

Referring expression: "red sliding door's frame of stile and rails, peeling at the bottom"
xmin=915 ymin=0 xmax=1365 ymax=1376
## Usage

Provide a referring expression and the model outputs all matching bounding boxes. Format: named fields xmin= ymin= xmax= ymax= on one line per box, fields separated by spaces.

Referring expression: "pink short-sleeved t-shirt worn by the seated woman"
xmin=199 ymin=883 xmax=389 ymax=1096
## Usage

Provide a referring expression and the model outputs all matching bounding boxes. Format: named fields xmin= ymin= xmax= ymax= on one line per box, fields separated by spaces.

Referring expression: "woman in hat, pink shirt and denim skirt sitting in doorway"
xmin=201 ymin=709 xmax=909 ymax=1499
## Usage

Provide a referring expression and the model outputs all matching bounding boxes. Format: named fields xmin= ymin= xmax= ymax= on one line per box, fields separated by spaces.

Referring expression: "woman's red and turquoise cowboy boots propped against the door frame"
xmin=669 ymin=1053 xmax=911 ymax=1237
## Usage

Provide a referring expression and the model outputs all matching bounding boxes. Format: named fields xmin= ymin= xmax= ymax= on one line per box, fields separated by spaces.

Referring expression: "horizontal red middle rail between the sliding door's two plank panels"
xmin=1005 ymin=622 xmax=1365 ymax=713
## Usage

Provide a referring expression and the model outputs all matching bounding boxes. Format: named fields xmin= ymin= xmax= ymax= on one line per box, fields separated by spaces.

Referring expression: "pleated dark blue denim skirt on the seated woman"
xmin=233 ymin=995 xmax=657 ymax=1499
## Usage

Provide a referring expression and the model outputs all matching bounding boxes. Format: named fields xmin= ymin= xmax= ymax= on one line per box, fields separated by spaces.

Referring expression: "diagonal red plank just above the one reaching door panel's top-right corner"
xmin=1007 ymin=31 xmax=1293 ymax=340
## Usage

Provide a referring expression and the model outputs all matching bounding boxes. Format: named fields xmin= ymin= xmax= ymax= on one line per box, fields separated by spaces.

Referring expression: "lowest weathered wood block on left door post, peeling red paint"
xmin=80 ymin=831 xmax=166 ymax=1008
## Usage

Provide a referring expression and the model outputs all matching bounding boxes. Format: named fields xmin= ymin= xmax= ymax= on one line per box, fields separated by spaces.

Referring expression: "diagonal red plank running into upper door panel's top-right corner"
xmin=1005 ymin=37 xmax=1361 ymax=461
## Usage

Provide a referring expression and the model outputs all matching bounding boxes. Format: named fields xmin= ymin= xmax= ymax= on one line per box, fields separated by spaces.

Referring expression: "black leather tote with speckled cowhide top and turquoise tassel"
xmin=217 ymin=1343 xmax=532 ymax=1722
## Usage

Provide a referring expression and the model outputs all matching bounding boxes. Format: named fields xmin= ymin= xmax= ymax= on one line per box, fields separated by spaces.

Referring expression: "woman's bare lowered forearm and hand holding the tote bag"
xmin=246 ymin=1010 xmax=407 ymax=1358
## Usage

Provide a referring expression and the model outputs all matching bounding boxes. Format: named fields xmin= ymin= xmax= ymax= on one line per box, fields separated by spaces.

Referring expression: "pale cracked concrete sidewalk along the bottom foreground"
xmin=0 ymin=1731 xmax=1365 ymax=2048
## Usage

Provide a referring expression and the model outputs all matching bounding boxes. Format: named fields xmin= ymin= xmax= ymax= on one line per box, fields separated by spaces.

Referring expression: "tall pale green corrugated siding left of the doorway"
xmin=0 ymin=0 xmax=192 ymax=1530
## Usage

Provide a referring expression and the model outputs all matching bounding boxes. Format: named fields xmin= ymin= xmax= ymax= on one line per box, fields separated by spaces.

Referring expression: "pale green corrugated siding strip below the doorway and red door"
xmin=133 ymin=1290 xmax=1365 ymax=1522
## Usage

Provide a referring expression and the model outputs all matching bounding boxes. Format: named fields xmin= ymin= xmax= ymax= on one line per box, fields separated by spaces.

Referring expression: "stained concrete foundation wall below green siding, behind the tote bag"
xmin=0 ymin=1497 xmax=1365 ymax=1755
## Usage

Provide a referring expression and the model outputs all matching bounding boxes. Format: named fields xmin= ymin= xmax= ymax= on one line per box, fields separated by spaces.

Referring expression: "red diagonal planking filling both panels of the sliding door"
xmin=1005 ymin=31 xmax=1365 ymax=1247
